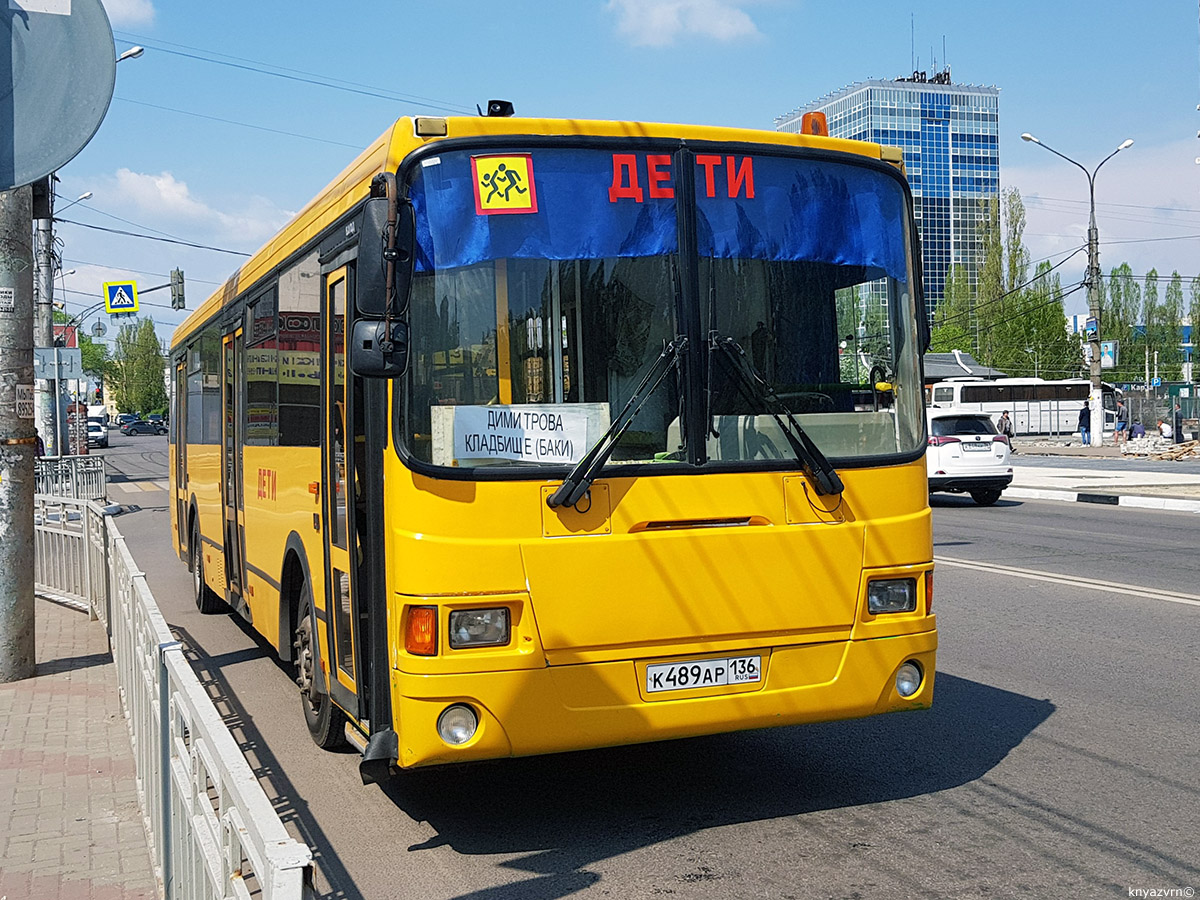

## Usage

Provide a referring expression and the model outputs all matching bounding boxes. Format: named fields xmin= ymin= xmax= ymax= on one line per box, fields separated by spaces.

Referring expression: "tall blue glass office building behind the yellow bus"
xmin=775 ymin=67 xmax=1000 ymax=317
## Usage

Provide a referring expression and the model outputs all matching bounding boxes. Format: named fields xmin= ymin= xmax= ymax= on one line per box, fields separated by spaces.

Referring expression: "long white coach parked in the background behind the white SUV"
xmin=926 ymin=377 xmax=1121 ymax=434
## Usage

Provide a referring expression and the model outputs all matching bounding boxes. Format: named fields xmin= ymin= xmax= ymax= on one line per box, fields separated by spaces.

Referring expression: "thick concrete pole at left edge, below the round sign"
xmin=0 ymin=187 xmax=36 ymax=683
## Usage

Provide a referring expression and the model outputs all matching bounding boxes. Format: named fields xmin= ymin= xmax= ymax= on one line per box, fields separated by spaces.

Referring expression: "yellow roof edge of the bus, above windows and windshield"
xmin=172 ymin=116 xmax=904 ymax=349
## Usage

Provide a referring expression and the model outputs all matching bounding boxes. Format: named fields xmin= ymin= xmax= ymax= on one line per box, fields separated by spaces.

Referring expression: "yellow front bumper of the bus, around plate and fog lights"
xmin=391 ymin=619 xmax=937 ymax=768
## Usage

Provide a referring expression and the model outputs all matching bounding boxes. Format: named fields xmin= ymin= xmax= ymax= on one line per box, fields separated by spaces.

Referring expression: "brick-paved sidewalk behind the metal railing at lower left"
xmin=0 ymin=599 xmax=158 ymax=900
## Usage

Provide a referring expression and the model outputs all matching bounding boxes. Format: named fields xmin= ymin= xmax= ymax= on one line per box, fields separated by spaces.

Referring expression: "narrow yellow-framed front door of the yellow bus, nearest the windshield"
xmin=322 ymin=266 xmax=362 ymax=724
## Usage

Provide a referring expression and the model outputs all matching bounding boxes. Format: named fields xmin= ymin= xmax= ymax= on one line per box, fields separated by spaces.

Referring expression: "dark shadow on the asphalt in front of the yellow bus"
xmin=372 ymin=672 xmax=1055 ymax=900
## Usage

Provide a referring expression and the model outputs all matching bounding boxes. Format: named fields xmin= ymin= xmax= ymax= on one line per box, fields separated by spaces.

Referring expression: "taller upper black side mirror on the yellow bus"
xmin=355 ymin=197 xmax=416 ymax=318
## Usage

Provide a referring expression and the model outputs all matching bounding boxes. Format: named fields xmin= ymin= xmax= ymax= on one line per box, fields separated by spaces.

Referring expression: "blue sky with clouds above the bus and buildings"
xmin=51 ymin=0 xmax=1200 ymax=348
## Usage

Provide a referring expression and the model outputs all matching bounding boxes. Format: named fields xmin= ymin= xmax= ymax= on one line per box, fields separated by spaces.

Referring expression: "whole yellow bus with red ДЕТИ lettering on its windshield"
xmin=170 ymin=104 xmax=937 ymax=781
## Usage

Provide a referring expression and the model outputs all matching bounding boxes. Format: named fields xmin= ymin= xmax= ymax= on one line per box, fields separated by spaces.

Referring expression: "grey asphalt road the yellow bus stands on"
xmin=98 ymin=434 xmax=1200 ymax=900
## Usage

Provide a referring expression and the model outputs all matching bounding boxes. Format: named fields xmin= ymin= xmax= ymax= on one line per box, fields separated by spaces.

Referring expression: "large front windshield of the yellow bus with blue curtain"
xmin=398 ymin=144 xmax=924 ymax=475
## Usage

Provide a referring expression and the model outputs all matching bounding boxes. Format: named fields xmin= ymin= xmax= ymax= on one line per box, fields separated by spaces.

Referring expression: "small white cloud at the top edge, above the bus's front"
xmin=608 ymin=0 xmax=762 ymax=47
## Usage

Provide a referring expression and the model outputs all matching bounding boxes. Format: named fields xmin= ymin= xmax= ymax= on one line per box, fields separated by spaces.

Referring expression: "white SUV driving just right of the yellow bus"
xmin=925 ymin=407 xmax=1013 ymax=506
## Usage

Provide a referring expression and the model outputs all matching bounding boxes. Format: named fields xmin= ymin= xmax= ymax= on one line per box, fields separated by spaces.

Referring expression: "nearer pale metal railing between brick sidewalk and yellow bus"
xmin=35 ymin=496 xmax=313 ymax=900
